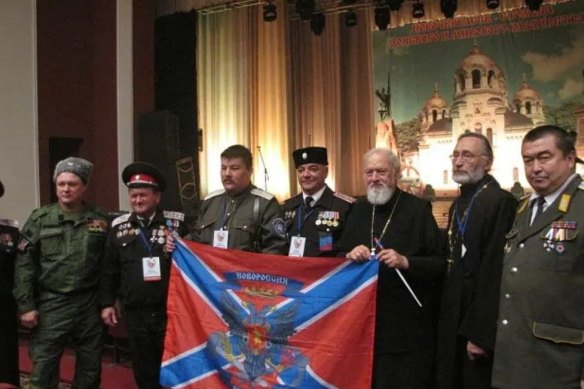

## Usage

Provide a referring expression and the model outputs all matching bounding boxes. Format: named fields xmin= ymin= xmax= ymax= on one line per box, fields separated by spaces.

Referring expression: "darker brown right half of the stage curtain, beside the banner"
xmin=289 ymin=12 xmax=374 ymax=194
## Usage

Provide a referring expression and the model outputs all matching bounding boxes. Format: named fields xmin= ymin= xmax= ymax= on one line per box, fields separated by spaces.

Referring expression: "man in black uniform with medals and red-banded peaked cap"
xmin=100 ymin=162 xmax=187 ymax=389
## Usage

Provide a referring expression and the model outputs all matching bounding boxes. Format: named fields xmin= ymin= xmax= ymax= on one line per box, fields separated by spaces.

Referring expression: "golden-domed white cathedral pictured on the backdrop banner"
xmin=412 ymin=44 xmax=545 ymax=192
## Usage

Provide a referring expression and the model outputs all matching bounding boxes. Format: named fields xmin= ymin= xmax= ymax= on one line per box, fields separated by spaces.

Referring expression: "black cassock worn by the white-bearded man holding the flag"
xmin=338 ymin=189 xmax=446 ymax=389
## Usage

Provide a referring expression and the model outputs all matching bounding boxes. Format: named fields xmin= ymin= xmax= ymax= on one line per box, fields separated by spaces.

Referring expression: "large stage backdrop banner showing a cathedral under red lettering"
xmin=373 ymin=1 xmax=584 ymax=196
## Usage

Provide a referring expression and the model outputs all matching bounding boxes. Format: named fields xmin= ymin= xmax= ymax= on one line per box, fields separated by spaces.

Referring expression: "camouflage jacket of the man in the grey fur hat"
xmin=14 ymin=203 xmax=107 ymax=313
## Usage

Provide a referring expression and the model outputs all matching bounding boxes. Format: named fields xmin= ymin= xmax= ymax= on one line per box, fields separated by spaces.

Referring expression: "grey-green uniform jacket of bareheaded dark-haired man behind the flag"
xmin=192 ymin=185 xmax=287 ymax=254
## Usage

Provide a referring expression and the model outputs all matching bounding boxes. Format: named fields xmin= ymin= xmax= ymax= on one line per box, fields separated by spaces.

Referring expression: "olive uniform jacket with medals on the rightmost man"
xmin=492 ymin=176 xmax=584 ymax=389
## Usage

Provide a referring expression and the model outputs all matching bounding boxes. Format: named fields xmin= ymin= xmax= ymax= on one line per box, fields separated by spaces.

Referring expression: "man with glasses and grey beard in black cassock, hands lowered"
xmin=436 ymin=132 xmax=517 ymax=389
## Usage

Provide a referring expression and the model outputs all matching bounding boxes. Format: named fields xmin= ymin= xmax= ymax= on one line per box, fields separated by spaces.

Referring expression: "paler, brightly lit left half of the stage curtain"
xmin=197 ymin=2 xmax=290 ymax=199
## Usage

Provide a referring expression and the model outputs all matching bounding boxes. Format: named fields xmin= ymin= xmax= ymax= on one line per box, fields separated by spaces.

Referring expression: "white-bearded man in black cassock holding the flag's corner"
xmin=338 ymin=148 xmax=446 ymax=389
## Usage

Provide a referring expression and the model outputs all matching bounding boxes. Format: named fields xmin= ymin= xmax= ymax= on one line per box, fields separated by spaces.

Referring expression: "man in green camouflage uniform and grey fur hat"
xmin=14 ymin=158 xmax=107 ymax=389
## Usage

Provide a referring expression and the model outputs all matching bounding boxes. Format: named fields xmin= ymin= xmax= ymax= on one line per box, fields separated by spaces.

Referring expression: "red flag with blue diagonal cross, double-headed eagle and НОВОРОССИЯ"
xmin=160 ymin=240 xmax=379 ymax=389
